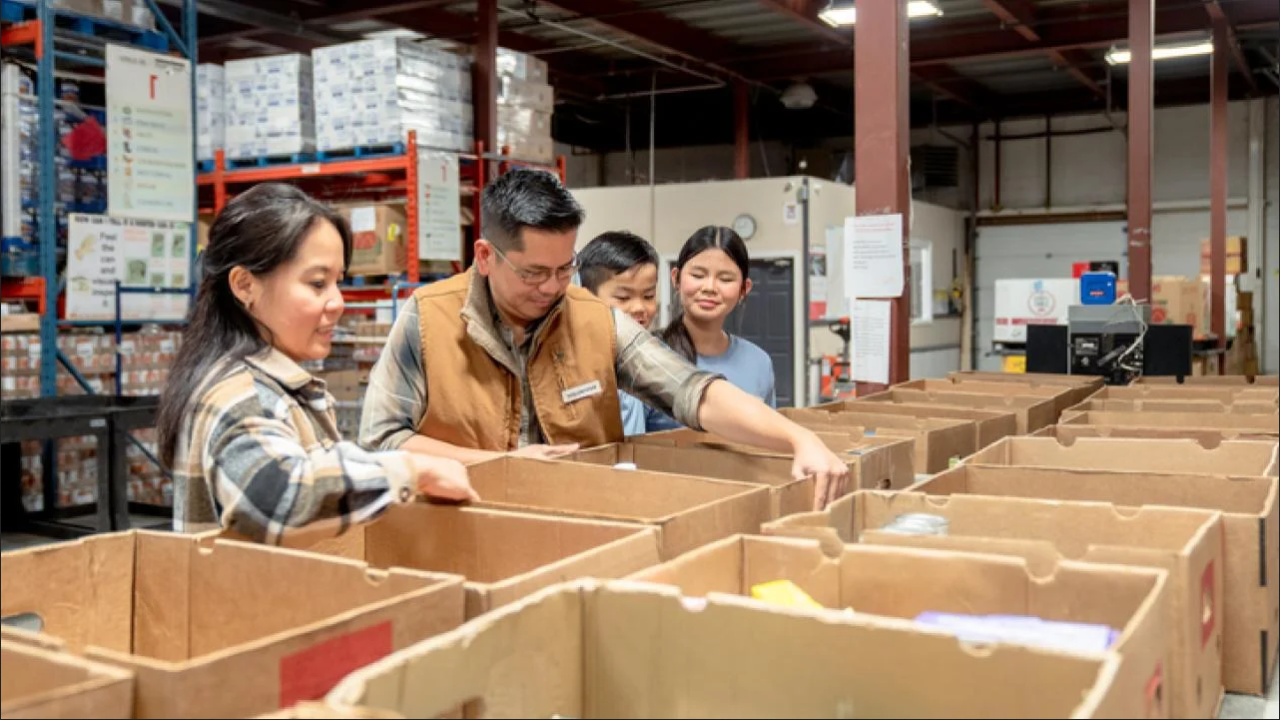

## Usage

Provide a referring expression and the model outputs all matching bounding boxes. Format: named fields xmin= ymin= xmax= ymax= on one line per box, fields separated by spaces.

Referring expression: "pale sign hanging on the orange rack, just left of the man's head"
xmin=417 ymin=150 xmax=462 ymax=261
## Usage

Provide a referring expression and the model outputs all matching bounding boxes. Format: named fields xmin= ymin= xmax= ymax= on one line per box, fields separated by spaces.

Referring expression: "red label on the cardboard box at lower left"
xmin=280 ymin=621 xmax=392 ymax=707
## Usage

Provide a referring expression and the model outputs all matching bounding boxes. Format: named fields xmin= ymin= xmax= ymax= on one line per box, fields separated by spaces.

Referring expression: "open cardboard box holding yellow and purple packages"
xmin=630 ymin=536 xmax=1170 ymax=717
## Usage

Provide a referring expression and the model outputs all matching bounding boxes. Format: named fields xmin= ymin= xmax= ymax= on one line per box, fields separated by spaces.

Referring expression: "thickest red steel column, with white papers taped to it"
xmin=854 ymin=0 xmax=911 ymax=386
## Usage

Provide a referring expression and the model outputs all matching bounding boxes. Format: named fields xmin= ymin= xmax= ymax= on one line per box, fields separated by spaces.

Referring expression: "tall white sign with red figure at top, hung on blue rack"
xmin=106 ymin=45 xmax=196 ymax=223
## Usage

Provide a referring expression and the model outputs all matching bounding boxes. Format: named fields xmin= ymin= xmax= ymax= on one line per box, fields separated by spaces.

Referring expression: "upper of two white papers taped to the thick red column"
xmin=845 ymin=214 xmax=905 ymax=300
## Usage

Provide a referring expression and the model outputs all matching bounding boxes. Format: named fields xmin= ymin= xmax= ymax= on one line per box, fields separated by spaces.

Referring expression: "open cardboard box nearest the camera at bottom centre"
xmin=329 ymin=580 xmax=1142 ymax=717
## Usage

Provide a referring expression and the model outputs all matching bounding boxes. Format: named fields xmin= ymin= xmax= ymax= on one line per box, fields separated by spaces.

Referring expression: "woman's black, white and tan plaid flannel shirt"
xmin=173 ymin=348 xmax=416 ymax=544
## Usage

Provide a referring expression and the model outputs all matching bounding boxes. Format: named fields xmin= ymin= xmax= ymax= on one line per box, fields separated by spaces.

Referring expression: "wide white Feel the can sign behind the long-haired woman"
xmin=67 ymin=214 xmax=192 ymax=320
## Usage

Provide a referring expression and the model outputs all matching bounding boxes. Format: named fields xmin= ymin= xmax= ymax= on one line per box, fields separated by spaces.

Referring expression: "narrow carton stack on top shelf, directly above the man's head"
xmin=494 ymin=49 xmax=556 ymax=163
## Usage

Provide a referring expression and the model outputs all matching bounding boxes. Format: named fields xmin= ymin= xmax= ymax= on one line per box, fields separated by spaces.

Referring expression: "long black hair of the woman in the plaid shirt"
xmin=156 ymin=183 xmax=351 ymax=468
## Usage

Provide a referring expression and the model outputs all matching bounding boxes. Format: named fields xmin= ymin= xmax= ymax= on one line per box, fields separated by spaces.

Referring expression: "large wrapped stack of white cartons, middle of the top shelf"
xmin=311 ymin=37 xmax=474 ymax=151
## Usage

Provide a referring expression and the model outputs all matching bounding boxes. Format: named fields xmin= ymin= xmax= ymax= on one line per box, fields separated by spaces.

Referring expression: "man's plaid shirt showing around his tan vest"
xmin=360 ymin=274 xmax=721 ymax=450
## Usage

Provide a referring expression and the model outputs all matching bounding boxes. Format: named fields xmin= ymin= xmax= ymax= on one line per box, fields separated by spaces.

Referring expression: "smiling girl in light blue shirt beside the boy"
xmin=645 ymin=225 xmax=777 ymax=433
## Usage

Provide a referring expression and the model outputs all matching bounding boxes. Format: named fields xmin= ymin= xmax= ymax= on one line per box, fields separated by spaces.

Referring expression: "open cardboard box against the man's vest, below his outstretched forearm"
xmin=561 ymin=442 xmax=815 ymax=520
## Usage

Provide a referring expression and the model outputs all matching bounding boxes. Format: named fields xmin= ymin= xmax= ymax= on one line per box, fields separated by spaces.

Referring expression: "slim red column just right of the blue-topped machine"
xmin=1129 ymin=0 xmax=1156 ymax=302
